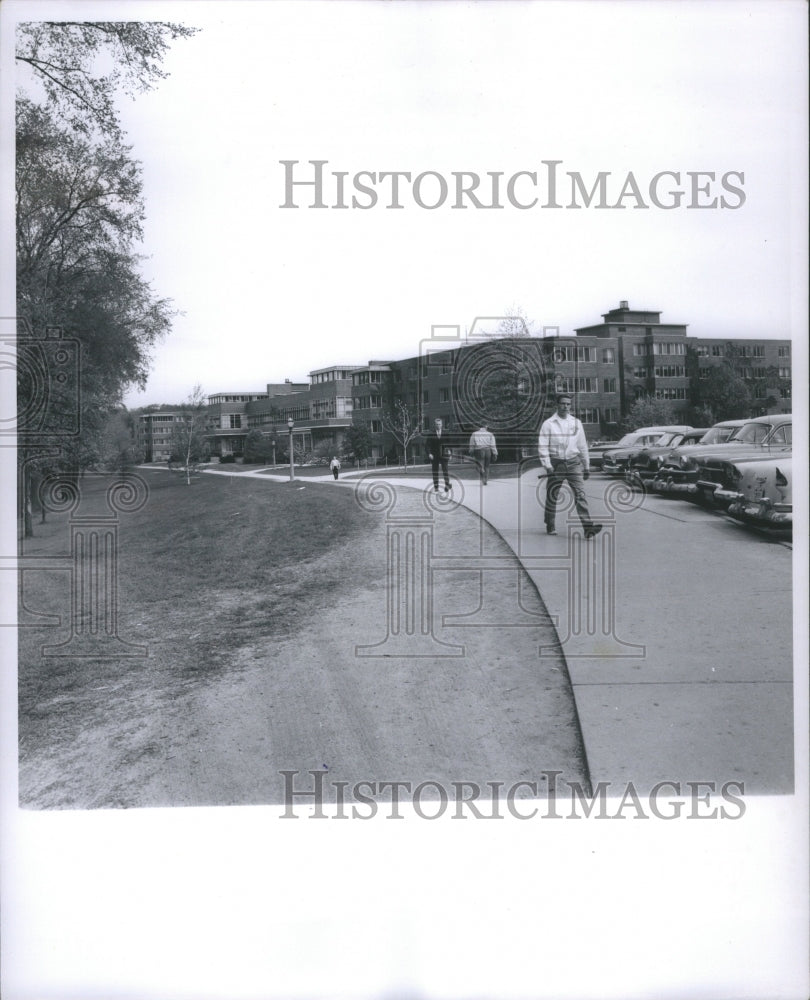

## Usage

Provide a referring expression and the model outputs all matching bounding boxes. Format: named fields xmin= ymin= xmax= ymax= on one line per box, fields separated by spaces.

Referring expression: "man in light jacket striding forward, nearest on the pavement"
xmin=537 ymin=393 xmax=602 ymax=538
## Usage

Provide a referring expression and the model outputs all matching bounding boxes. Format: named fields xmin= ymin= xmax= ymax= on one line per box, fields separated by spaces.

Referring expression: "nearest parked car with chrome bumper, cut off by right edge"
xmin=714 ymin=453 xmax=793 ymax=529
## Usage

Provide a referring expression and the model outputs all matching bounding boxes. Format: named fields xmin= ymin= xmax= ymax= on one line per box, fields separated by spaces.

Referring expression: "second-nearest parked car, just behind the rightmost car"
xmin=652 ymin=413 xmax=793 ymax=499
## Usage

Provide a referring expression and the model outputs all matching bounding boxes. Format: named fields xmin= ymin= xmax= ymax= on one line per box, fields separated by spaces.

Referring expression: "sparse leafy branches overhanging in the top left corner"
xmin=16 ymin=21 xmax=199 ymax=138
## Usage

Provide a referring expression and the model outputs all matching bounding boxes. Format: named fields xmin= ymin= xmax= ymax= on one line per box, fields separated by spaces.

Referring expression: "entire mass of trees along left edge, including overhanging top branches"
xmin=16 ymin=22 xmax=196 ymax=535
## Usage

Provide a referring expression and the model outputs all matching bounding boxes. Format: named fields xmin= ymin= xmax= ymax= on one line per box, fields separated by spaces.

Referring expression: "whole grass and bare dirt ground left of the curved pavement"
xmin=19 ymin=470 xmax=585 ymax=809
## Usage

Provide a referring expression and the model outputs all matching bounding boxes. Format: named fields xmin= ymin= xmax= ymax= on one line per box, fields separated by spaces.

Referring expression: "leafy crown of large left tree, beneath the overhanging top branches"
xmin=17 ymin=100 xmax=172 ymax=390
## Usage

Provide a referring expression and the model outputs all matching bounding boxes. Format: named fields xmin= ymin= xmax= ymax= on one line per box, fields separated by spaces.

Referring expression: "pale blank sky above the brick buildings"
xmin=6 ymin=0 xmax=805 ymax=406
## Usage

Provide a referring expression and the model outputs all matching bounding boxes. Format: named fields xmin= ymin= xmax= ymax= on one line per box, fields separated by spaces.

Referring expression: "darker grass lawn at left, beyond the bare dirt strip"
xmin=19 ymin=471 xmax=385 ymax=806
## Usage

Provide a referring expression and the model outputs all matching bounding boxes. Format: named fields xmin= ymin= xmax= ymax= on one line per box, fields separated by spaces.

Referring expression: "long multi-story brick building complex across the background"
xmin=188 ymin=301 xmax=791 ymax=459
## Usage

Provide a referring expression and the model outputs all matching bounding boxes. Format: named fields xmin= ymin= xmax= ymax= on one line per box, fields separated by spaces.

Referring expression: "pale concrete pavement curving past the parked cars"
xmin=366 ymin=469 xmax=793 ymax=794
